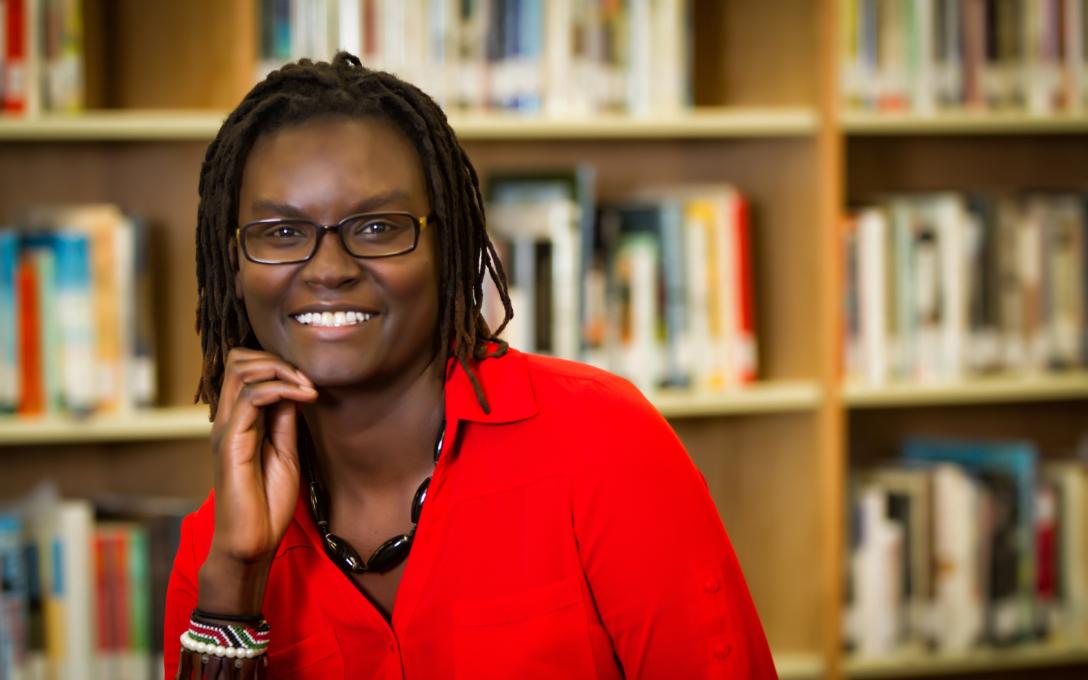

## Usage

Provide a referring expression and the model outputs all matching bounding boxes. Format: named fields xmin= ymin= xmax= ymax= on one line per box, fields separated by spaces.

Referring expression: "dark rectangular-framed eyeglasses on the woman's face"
xmin=235 ymin=212 xmax=431 ymax=264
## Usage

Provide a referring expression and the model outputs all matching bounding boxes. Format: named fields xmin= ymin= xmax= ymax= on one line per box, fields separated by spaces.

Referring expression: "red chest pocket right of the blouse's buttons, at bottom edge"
xmin=453 ymin=577 xmax=597 ymax=680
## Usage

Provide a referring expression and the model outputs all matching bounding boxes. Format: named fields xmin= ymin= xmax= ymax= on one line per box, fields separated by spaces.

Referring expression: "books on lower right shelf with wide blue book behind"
xmin=845 ymin=440 xmax=1088 ymax=656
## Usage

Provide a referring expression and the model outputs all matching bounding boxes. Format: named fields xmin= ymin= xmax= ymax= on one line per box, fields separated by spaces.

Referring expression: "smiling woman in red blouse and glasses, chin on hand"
xmin=165 ymin=53 xmax=775 ymax=679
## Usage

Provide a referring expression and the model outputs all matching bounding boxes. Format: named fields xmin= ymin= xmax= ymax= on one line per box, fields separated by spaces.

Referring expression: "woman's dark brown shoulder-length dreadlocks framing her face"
xmin=197 ymin=52 xmax=514 ymax=418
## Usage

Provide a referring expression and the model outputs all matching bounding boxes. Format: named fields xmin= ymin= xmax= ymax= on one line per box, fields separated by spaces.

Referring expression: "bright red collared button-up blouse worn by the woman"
xmin=164 ymin=350 xmax=776 ymax=680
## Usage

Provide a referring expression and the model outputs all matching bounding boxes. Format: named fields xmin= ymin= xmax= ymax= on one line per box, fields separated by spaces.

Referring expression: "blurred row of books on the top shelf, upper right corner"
xmin=841 ymin=0 xmax=1088 ymax=114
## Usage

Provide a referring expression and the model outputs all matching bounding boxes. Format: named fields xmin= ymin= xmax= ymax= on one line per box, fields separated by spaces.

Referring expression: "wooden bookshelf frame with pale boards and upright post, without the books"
xmin=0 ymin=0 xmax=1088 ymax=678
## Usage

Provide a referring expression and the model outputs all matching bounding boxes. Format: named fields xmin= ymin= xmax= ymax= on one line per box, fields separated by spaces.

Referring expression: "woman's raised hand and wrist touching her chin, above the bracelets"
xmin=199 ymin=348 xmax=318 ymax=614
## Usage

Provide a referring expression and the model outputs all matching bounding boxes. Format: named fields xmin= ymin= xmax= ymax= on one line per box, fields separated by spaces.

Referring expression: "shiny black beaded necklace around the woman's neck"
xmin=307 ymin=420 xmax=446 ymax=573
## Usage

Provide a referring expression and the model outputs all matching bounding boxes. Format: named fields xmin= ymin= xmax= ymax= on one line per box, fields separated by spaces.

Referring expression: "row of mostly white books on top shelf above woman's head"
xmin=259 ymin=0 xmax=691 ymax=115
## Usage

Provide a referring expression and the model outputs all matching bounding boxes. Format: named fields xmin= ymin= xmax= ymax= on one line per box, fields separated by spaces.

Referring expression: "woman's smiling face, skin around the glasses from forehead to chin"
xmin=235 ymin=119 xmax=438 ymax=387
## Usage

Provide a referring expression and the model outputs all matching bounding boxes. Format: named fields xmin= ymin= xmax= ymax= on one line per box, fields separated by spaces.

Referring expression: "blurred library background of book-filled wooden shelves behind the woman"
xmin=0 ymin=0 xmax=1088 ymax=680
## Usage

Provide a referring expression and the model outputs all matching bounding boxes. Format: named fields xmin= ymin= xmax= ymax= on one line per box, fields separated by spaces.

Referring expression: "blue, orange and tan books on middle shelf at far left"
xmin=0 ymin=205 xmax=157 ymax=416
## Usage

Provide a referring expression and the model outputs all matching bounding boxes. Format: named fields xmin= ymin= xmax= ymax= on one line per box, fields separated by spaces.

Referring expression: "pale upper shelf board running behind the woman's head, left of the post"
xmin=0 ymin=107 xmax=817 ymax=141
